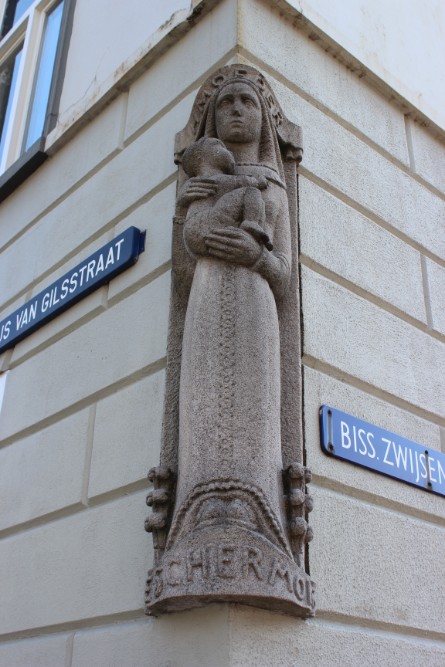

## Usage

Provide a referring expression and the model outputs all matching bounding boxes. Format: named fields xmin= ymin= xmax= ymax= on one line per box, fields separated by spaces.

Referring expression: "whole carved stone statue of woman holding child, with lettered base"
xmin=146 ymin=65 xmax=314 ymax=616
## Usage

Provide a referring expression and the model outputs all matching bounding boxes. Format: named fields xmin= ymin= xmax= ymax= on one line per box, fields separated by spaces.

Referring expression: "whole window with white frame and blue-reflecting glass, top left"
xmin=0 ymin=0 xmax=74 ymax=200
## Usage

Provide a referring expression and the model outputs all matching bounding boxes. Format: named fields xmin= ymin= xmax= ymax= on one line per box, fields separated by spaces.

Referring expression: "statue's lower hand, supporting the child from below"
xmin=204 ymin=227 xmax=263 ymax=267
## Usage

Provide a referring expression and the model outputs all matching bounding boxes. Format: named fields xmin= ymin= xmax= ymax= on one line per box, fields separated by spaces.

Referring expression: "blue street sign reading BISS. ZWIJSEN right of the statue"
xmin=320 ymin=405 xmax=445 ymax=496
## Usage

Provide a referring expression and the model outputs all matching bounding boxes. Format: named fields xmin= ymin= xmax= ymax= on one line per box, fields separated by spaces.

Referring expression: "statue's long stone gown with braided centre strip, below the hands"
xmin=173 ymin=174 xmax=289 ymax=550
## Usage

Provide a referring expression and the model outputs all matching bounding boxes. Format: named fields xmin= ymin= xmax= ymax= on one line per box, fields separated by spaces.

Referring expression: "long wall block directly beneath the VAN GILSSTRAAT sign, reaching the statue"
xmin=0 ymin=273 xmax=170 ymax=438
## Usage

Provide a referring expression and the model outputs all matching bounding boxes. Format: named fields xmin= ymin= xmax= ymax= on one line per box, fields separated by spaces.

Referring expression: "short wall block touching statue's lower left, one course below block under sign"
xmin=89 ymin=371 xmax=165 ymax=497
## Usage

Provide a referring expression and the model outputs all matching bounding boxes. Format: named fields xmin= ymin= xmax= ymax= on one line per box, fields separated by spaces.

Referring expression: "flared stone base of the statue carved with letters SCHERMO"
xmin=146 ymin=484 xmax=314 ymax=616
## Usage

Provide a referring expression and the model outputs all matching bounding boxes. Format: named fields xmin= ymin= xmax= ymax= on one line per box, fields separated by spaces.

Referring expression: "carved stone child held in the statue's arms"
xmin=182 ymin=137 xmax=273 ymax=256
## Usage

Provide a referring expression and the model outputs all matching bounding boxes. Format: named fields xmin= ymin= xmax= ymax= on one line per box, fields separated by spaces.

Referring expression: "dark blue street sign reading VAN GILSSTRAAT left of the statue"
xmin=0 ymin=227 xmax=145 ymax=353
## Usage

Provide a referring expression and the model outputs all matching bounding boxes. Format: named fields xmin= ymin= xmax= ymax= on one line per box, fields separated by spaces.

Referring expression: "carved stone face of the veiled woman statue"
xmin=215 ymin=83 xmax=262 ymax=144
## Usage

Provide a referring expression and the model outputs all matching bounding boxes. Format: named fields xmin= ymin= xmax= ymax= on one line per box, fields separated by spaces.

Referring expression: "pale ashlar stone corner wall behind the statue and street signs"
xmin=0 ymin=0 xmax=445 ymax=667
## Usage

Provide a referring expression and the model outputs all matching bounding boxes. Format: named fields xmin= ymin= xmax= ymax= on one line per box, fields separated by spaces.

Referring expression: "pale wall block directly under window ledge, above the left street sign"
xmin=0 ymin=95 xmax=126 ymax=254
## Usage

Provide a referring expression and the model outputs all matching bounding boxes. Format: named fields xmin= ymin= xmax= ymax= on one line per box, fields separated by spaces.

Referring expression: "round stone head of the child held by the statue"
xmin=182 ymin=137 xmax=235 ymax=177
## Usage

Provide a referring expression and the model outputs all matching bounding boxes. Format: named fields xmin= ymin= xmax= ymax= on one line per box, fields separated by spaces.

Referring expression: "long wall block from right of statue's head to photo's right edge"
xmin=268 ymin=76 xmax=445 ymax=257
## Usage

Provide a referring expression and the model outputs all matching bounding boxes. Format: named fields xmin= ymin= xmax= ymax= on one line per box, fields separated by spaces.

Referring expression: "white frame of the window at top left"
xmin=0 ymin=0 xmax=74 ymax=194
